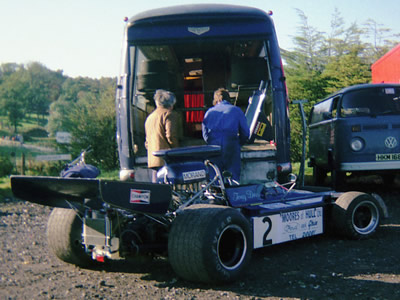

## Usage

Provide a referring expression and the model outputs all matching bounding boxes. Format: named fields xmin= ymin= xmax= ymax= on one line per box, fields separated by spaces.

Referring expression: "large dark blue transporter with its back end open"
xmin=116 ymin=5 xmax=291 ymax=183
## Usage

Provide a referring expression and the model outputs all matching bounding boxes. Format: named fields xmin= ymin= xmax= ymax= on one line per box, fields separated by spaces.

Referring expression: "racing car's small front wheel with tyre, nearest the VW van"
xmin=332 ymin=192 xmax=382 ymax=240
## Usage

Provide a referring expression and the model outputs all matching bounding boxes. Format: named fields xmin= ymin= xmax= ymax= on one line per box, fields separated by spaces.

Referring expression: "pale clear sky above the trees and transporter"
xmin=0 ymin=0 xmax=400 ymax=78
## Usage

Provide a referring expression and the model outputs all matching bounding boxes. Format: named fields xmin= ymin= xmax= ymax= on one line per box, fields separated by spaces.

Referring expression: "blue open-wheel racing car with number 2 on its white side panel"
xmin=11 ymin=145 xmax=387 ymax=283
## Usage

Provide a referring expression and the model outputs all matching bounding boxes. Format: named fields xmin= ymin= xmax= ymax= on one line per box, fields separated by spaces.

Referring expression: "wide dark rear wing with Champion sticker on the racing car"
xmin=11 ymin=176 xmax=172 ymax=214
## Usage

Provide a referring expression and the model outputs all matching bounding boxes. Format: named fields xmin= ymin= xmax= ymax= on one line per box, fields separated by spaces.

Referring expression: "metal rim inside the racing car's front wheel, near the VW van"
xmin=352 ymin=201 xmax=379 ymax=234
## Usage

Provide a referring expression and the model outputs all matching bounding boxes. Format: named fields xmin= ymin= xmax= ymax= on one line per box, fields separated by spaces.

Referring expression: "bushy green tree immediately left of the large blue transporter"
xmin=48 ymin=78 xmax=118 ymax=169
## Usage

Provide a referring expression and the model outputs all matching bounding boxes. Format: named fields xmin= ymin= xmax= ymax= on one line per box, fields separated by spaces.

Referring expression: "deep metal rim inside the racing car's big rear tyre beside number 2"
xmin=217 ymin=225 xmax=247 ymax=270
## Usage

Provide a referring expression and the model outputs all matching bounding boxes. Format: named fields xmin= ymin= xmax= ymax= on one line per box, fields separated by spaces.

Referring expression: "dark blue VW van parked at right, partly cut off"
xmin=309 ymin=84 xmax=400 ymax=187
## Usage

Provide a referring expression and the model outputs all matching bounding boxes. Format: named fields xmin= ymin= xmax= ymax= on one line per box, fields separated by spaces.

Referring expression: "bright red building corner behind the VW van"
xmin=371 ymin=44 xmax=400 ymax=83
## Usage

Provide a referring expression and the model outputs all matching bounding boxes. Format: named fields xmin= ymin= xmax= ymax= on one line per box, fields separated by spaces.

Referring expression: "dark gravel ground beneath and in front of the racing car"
xmin=0 ymin=180 xmax=400 ymax=299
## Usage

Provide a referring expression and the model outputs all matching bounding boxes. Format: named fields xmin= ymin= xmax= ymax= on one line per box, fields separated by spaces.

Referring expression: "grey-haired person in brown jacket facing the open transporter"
xmin=145 ymin=90 xmax=180 ymax=181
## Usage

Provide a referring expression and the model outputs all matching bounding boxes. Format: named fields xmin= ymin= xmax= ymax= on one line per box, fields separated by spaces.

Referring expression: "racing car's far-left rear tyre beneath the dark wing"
xmin=47 ymin=208 xmax=94 ymax=267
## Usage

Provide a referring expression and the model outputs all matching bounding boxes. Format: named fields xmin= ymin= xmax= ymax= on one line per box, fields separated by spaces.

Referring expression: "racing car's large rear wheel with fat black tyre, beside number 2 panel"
xmin=168 ymin=205 xmax=253 ymax=283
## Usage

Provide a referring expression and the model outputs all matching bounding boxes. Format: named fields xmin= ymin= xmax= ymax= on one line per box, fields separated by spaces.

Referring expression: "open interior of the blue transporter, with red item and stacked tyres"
xmin=129 ymin=39 xmax=274 ymax=156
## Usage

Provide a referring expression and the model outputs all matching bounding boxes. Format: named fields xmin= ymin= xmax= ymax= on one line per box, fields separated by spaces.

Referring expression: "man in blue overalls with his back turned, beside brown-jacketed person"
xmin=202 ymin=88 xmax=250 ymax=182
